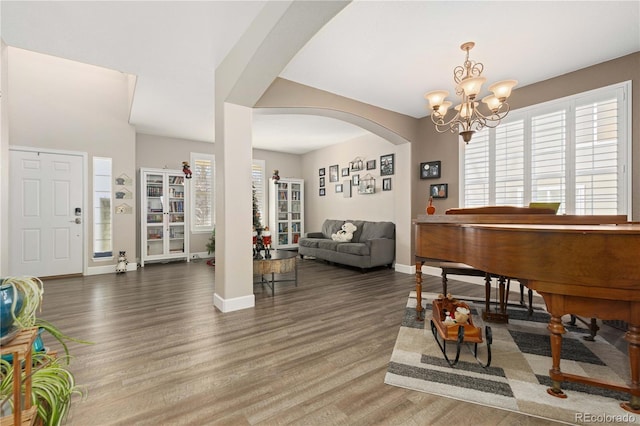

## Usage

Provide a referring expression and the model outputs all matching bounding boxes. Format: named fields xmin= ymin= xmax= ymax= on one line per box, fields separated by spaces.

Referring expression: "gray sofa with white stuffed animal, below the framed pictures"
xmin=298 ymin=219 xmax=396 ymax=269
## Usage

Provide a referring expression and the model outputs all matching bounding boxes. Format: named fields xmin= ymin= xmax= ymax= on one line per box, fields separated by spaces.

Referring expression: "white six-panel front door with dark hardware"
xmin=9 ymin=150 xmax=85 ymax=277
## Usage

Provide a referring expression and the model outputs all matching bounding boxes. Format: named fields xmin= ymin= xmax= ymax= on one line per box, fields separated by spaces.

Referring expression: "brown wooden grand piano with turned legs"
xmin=414 ymin=214 xmax=640 ymax=413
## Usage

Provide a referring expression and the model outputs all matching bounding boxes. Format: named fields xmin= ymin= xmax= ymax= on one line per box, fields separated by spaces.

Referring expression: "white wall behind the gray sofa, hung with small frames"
xmin=302 ymin=134 xmax=401 ymax=232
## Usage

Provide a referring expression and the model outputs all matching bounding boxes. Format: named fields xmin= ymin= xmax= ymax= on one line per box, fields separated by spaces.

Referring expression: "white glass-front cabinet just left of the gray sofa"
xmin=269 ymin=178 xmax=304 ymax=249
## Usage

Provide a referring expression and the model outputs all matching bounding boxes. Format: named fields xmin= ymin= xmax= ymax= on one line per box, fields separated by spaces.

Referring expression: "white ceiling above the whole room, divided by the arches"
xmin=0 ymin=0 xmax=640 ymax=153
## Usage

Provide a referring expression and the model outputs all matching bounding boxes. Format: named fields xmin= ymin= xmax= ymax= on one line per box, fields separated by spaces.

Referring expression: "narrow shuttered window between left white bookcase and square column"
xmin=190 ymin=152 xmax=215 ymax=232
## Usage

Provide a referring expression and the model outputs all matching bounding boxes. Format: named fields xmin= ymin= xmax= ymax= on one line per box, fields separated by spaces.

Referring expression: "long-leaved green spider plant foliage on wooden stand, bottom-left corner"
xmin=0 ymin=277 xmax=90 ymax=426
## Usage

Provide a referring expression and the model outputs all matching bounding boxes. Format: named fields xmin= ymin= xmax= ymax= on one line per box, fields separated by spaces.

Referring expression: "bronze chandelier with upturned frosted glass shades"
xmin=424 ymin=41 xmax=518 ymax=143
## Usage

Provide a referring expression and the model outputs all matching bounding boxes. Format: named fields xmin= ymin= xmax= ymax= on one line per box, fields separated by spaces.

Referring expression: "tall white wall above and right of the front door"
xmin=1 ymin=47 xmax=137 ymax=271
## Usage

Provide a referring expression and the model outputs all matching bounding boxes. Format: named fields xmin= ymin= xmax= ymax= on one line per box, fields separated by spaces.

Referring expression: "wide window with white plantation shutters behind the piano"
xmin=461 ymin=82 xmax=631 ymax=215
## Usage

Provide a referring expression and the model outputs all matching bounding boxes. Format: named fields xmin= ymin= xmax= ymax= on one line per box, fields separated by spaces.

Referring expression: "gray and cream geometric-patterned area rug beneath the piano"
xmin=385 ymin=292 xmax=640 ymax=424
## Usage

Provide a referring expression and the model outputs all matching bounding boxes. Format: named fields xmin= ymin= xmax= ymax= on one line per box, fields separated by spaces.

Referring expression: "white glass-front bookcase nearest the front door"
xmin=140 ymin=169 xmax=189 ymax=266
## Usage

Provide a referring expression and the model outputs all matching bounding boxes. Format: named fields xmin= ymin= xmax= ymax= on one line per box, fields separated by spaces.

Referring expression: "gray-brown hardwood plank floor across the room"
xmin=40 ymin=259 xmax=600 ymax=426
